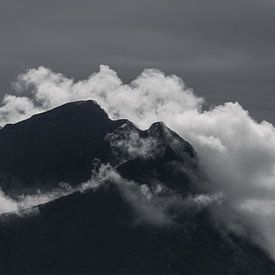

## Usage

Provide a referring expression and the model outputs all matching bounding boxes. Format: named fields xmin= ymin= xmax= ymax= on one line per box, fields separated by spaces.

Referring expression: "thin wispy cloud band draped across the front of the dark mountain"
xmin=0 ymin=164 xmax=224 ymax=227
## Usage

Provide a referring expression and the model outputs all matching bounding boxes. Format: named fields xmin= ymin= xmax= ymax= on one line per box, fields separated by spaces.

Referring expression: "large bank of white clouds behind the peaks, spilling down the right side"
xmin=0 ymin=65 xmax=275 ymax=259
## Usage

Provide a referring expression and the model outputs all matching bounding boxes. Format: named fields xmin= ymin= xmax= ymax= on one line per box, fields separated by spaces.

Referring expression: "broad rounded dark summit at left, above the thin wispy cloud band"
xmin=0 ymin=101 xmax=126 ymax=193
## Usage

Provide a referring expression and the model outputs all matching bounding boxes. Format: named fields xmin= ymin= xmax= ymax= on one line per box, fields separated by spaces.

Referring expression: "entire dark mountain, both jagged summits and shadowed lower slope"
xmin=0 ymin=101 xmax=275 ymax=275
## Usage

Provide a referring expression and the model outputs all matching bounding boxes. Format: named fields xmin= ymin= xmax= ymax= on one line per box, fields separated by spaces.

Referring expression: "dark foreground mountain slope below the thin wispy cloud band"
xmin=0 ymin=186 xmax=275 ymax=275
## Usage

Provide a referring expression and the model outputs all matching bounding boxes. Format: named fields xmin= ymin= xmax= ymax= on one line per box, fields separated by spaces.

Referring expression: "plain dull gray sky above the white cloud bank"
xmin=0 ymin=0 xmax=275 ymax=123
